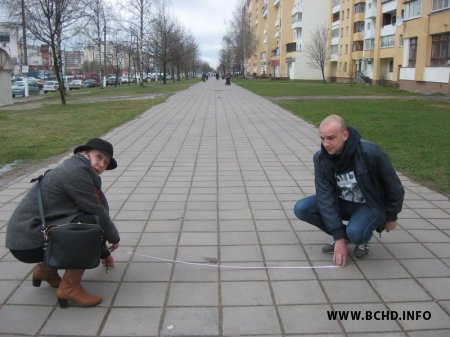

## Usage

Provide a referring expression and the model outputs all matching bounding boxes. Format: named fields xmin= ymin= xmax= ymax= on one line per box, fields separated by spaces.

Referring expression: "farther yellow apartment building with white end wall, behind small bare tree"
xmin=246 ymin=0 xmax=329 ymax=80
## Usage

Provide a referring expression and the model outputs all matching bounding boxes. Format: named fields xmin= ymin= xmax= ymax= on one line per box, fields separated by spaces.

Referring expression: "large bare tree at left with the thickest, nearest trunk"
xmin=25 ymin=0 xmax=85 ymax=104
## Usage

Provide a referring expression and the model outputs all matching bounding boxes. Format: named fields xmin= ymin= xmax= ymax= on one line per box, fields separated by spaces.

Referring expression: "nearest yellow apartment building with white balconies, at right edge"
xmin=328 ymin=0 xmax=450 ymax=94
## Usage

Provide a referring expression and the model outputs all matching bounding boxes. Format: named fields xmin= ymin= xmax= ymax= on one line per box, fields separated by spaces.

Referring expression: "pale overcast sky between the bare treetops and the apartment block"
xmin=172 ymin=0 xmax=242 ymax=68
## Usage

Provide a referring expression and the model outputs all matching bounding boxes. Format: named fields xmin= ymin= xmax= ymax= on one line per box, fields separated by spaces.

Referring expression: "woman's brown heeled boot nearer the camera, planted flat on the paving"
xmin=56 ymin=269 xmax=102 ymax=308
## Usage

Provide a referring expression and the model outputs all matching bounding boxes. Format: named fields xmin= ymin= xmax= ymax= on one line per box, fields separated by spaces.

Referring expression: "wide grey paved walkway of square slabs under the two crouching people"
xmin=0 ymin=79 xmax=450 ymax=337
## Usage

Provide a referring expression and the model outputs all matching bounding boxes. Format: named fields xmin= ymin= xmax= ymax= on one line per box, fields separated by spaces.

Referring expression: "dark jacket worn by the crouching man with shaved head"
xmin=313 ymin=127 xmax=405 ymax=240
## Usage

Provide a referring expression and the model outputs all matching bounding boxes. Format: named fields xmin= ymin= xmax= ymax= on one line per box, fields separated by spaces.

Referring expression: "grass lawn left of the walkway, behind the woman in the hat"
xmin=0 ymin=80 xmax=198 ymax=168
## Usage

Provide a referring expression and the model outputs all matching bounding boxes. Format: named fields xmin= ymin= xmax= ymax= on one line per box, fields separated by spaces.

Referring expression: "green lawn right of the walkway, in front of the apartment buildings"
xmin=234 ymin=80 xmax=450 ymax=195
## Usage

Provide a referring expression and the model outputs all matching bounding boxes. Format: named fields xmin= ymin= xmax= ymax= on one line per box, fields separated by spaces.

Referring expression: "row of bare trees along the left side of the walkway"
xmin=0 ymin=0 xmax=205 ymax=104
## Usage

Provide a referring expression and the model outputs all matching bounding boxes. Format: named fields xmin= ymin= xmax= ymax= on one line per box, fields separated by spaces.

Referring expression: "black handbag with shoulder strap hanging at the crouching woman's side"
xmin=32 ymin=173 xmax=103 ymax=269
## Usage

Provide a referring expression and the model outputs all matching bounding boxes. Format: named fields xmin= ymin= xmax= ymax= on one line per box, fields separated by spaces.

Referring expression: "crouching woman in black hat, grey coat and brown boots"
xmin=6 ymin=138 xmax=120 ymax=307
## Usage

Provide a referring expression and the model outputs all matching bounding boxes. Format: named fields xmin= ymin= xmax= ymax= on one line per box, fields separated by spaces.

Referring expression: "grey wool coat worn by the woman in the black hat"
xmin=6 ymin=154 xmax=120 ymax=250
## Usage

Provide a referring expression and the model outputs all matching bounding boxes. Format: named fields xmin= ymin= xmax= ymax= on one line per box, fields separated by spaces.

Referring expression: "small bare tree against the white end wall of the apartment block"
xmin=303 ymin=24 xmax=331 ymax=82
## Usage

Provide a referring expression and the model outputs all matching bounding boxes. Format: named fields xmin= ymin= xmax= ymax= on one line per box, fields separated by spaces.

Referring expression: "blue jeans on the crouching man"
xmin=294 ymin=195 xmax=385 ymax=245
